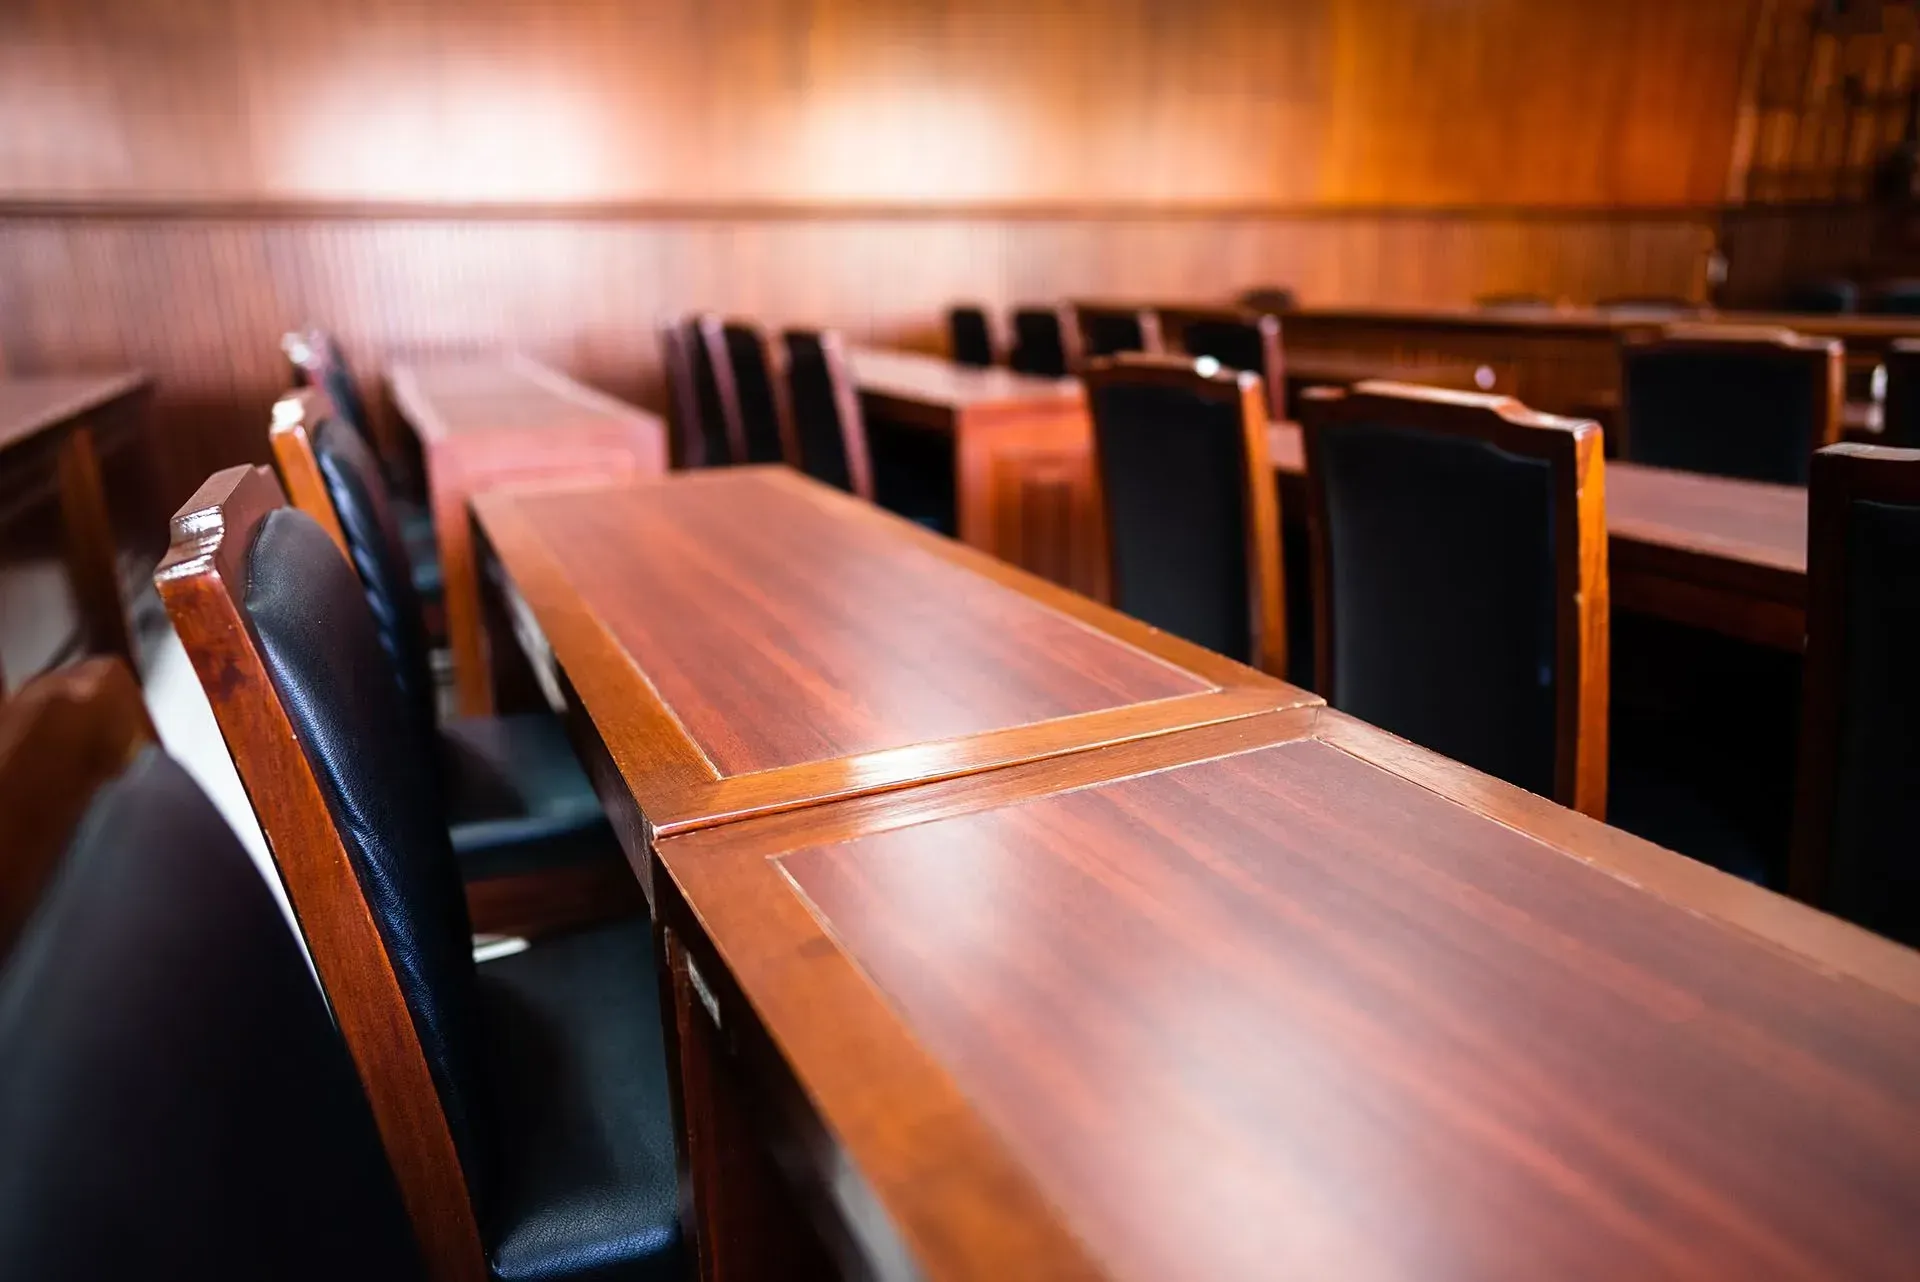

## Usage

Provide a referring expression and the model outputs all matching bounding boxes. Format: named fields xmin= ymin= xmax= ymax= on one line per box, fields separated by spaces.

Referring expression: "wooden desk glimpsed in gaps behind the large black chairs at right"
xmin=1267 ymin=422 xmax=1807 ymax=653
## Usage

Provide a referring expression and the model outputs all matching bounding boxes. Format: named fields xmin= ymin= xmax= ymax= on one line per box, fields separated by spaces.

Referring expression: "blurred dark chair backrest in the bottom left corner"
xmin=0 ymin=664 xmax=422 ymax=1280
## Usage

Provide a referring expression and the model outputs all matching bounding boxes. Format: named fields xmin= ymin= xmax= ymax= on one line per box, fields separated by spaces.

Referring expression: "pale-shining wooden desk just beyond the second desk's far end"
xmin=388 ymin=355 xmax=666 ymax=716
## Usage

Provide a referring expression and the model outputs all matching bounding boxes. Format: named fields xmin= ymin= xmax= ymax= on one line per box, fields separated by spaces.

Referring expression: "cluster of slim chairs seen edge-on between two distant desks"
xmin=659 ymin=313 xmax=874 ymax=499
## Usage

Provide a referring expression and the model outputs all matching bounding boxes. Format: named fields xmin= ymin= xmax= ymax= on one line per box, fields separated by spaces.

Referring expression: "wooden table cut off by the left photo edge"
xmin=0 ymin=372 xmax=152 ymax=693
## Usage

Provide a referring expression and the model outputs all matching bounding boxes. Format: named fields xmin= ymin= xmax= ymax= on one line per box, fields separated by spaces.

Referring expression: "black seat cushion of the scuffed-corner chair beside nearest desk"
xmin=480 ymin=919 xmax=685 ymax=1282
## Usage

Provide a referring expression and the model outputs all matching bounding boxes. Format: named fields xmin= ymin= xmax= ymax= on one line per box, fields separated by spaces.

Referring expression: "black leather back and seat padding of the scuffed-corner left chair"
xmin=244 ymin=509 xmax=685 ymax=1282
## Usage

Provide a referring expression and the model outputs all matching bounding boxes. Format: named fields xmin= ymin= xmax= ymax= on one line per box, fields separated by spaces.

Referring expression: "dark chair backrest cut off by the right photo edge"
xmin=1789 ymin=445 xmax=1920 ymax=948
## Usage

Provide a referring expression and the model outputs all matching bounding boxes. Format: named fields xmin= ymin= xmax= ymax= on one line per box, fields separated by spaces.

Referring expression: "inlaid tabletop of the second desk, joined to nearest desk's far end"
xmin=474 ymin=468 xmax=1315 ymax=854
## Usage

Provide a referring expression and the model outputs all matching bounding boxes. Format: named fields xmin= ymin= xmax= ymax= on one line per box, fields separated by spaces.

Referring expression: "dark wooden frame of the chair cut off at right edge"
xmin=1788 ymin=445 xmax=1920 ymax=908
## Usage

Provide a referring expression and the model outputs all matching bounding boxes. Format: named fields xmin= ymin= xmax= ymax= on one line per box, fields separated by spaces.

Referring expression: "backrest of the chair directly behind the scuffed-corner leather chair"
xmin=267 ymin=390 xmax=440 ymax=739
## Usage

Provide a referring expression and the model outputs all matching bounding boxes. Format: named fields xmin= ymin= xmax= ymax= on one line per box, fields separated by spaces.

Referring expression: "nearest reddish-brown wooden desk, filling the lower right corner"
xmin=659 ymin=708 xmax=1920 ymax=1282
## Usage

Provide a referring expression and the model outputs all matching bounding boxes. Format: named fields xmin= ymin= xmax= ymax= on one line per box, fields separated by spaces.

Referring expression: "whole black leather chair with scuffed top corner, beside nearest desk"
xmin=156 ymin=468 xmax=685 ymax=1280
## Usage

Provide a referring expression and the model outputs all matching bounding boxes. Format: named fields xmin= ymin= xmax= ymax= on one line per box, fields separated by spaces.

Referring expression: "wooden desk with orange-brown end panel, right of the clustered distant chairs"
xmin=851 ymin=347 xmax=1106 ymax=599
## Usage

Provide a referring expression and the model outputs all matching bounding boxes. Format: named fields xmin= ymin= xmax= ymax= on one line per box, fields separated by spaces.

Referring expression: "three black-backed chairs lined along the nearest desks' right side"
xmin=1085 ymin=355 xmax=1920 ymax=942
